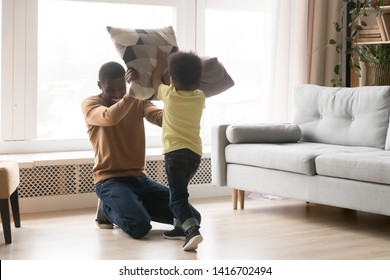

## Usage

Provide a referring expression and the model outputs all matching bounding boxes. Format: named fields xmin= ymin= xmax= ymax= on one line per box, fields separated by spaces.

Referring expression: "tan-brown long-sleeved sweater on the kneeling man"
xmin=81 ymin=94 xmax=162 ymax=183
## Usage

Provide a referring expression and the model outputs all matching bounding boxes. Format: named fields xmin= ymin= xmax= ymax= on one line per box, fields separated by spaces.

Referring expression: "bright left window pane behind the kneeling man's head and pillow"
xmin=37 ymin=0 xmax=176 ymax=139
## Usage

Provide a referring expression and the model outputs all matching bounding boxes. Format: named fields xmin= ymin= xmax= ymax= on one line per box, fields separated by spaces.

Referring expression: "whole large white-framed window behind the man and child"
xmin=0 ymin=0 xmax=286 ymax=153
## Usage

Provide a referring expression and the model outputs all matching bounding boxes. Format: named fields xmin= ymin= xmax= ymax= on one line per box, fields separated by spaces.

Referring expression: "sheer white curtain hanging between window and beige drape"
xmin=267 ymin=0 xmax=310 ymax=122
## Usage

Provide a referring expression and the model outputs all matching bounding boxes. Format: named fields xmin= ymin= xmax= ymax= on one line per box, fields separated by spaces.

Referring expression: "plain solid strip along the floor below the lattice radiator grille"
xmin=19 ymin=185 xmax=230 ymax=214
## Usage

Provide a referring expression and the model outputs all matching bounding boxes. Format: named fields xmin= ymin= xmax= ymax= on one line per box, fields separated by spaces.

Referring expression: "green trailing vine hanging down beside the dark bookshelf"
xmin=329 ymin=0 xmax=389 ymax=86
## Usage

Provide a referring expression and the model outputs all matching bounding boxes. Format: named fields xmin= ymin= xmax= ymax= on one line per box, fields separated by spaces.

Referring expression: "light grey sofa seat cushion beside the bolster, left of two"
xmin=225 ymin=142 xmax=380 ymax=175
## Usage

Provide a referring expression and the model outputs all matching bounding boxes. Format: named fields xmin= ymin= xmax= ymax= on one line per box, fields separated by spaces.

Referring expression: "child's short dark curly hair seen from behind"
xmin=168 ymin=51 xmax=202 ymax=90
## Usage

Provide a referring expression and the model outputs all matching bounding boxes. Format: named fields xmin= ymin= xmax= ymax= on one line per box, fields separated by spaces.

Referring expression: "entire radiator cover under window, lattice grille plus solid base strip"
xmin=19 ymin=158 xmax=229 ymax=213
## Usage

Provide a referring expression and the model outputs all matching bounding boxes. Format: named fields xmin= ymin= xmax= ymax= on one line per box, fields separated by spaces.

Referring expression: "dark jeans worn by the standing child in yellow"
xmin=165 ymin=149 xmax=201 ymax=231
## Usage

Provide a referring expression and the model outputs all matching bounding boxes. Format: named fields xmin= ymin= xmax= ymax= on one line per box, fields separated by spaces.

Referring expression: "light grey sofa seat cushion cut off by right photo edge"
xmin=315 ymin=150 xmax=390 ymax=184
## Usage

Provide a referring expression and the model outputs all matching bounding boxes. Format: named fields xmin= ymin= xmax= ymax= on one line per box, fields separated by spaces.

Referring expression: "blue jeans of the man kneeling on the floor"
xmin=95 ymin=176 xmax=200 ymax=239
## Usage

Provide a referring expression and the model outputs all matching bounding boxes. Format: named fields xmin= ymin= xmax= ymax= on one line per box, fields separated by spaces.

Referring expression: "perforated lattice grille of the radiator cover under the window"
xmin=19 ymin=158 xmax=211 ymax=198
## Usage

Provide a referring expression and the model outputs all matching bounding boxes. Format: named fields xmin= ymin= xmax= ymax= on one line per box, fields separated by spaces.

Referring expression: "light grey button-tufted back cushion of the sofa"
xmin=293 ymin=85 xmax=390 ymax=149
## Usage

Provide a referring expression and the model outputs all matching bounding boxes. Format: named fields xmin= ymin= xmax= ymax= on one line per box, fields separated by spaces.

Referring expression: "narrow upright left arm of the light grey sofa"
xmin=211 ymin=124 xmax=229 ymax=186
